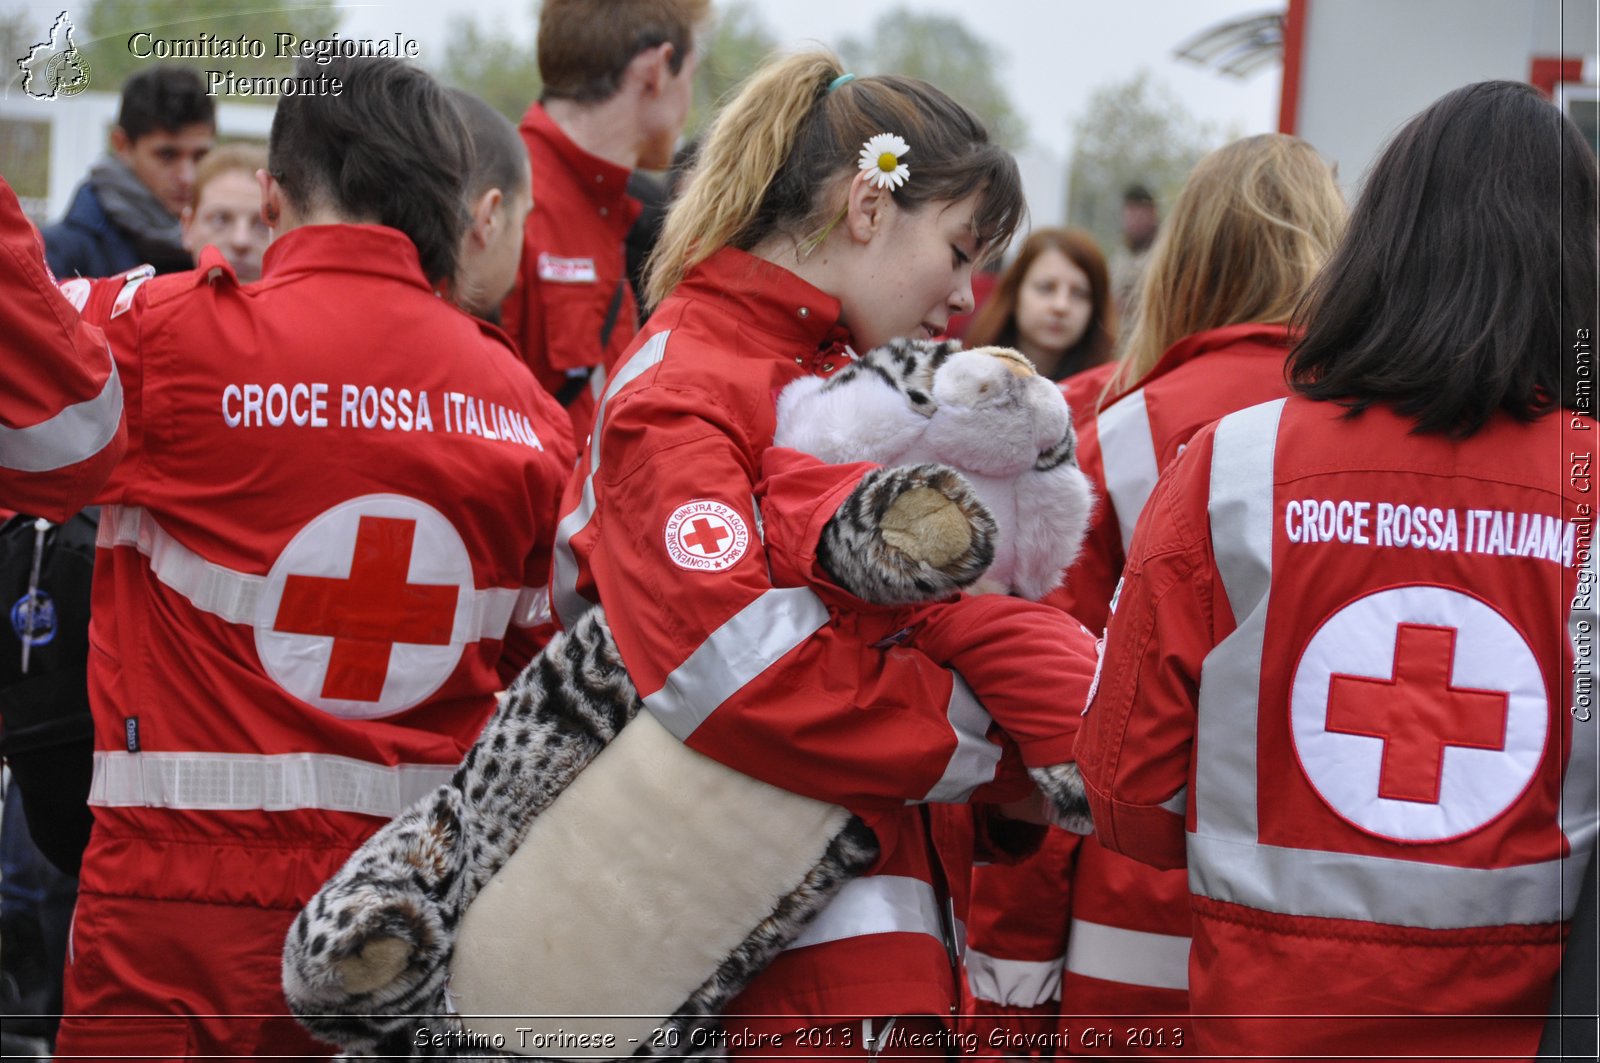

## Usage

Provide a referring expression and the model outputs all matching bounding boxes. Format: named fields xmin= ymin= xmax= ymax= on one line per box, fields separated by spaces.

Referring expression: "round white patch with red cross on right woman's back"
xmin=1290 ymin=584 xmax=1550 ymax=842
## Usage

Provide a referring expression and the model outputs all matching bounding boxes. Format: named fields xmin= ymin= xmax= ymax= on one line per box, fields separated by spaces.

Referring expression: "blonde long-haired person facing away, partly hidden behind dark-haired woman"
xmin=968 ymin=134 xmax=1346 ymax=1057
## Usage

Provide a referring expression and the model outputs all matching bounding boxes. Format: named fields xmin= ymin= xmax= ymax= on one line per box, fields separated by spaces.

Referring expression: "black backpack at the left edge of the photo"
xmin=0 ymin=507 xmax=99 ymax=874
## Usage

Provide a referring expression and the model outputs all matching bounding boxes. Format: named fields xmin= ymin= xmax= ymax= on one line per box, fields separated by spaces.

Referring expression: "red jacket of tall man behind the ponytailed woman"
xmin=501 ymin=102 xmax=643 ymax=440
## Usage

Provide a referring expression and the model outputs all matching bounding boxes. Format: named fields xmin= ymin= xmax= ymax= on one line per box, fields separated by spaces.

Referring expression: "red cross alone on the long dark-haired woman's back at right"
xmin=1328 ymin=624 xmax=1509 ymax=804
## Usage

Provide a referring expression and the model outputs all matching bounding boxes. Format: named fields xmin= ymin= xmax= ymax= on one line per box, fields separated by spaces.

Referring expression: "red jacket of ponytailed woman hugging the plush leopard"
xmin=552 ymin=250 xmax=1086 ymax=1017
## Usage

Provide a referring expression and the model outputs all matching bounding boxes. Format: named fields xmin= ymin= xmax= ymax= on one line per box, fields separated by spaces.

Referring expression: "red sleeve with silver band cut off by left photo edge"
xmin=0 ymin=179 xmax=128 ymax=520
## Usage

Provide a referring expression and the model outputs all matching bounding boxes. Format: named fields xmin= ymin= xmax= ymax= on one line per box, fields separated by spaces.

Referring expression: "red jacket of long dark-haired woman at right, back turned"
xmin=1078 ymin=399 xmax=1597 ymax=1058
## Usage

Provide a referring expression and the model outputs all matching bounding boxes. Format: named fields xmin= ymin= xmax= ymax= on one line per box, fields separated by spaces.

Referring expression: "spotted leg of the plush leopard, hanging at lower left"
xmin=283 ymin=608 xmax=642 ymax=1055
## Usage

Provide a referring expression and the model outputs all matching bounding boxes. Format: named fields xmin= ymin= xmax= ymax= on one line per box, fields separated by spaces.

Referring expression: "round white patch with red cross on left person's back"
xmin=256 ymin=495 xmax=477 ymax=719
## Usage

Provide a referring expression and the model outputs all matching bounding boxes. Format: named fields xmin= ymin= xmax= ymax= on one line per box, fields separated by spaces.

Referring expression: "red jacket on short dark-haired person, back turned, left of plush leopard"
xmin=58 ymin=226 xmax=573 ymax=1053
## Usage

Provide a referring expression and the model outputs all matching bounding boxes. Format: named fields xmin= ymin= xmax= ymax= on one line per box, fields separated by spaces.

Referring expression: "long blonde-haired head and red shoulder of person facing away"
xmin=1062 ymin=133 xmax=1346 ymax=629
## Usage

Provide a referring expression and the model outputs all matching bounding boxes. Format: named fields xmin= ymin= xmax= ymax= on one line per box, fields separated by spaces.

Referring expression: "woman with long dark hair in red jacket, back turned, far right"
xmin=1077 ymin=82 xmax=1600 ymax=1060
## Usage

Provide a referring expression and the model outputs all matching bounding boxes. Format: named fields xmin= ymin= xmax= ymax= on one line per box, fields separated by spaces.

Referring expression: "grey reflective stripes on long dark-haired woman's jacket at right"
xmin=1187 ymin=399 xmax=1600 ymax=929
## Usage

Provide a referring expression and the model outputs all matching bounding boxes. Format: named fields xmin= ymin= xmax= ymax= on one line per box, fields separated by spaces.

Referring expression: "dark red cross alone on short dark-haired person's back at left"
xmin=274 ymin=517 xmax=461 ymax=701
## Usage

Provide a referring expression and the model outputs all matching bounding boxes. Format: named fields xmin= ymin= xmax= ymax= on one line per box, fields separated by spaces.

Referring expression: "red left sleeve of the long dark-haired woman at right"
xmin=1077 ymin=429 xmax=1230 ymax=868
